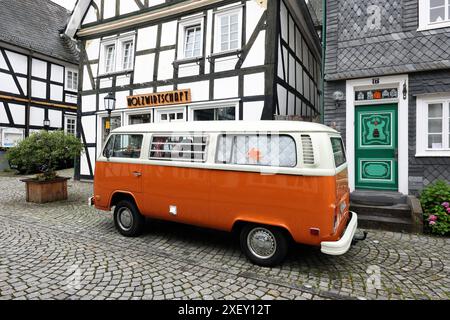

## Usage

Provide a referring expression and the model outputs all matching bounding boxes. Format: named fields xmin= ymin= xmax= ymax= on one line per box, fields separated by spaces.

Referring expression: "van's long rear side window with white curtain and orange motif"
xmin=216 ymin=134 xmax=297 ymax=167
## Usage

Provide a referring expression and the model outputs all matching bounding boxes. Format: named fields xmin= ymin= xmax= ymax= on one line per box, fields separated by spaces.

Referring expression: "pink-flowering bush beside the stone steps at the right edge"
xmin=420 ymin=181 xmax=450 ymax=235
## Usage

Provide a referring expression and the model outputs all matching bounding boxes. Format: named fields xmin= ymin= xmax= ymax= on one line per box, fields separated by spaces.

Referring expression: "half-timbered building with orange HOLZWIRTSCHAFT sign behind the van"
xmin=65 ymin=0 xmax=321 ymax=178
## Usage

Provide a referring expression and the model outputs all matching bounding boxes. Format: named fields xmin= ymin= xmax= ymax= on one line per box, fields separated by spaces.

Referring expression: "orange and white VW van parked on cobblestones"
xmin=90 ymin=121 xmax=357 ymax=266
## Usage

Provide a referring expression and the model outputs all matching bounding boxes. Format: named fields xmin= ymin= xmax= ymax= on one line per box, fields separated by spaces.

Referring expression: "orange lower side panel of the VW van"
xmin=94 ymin=162 xmax=346 ymax=245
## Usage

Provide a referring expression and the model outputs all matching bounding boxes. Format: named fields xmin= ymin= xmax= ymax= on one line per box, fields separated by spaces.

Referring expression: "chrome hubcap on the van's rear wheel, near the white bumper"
xmin=247 ymin=228 xmax=277 ymax=259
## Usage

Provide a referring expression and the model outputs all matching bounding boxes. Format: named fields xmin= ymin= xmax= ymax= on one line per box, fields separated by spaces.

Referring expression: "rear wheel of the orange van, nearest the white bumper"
xmin=240 ymin=224 xmax=289 ymax=267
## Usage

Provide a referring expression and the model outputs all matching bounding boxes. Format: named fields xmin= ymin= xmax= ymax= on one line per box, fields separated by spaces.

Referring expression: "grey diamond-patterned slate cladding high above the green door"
xmin=325 ymin=0 xmax=450 ymax=80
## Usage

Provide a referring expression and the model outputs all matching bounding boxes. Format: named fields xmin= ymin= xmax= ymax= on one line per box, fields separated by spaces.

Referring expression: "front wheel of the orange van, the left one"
xmin=114 ymin=200 xmax=145 ymax=237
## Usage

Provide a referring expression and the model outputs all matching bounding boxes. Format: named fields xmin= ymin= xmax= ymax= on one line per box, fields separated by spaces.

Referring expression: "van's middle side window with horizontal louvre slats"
xmin=150 ymin=135 xmax=207 ymax=162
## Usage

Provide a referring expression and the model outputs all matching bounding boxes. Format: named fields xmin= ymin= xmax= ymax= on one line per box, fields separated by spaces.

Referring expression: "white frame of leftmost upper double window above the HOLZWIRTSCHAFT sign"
xmin=100 ymin=33 xmax=136 ymax=75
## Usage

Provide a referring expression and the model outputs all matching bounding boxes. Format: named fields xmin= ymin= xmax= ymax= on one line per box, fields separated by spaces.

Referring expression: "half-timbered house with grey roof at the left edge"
xmin=0 ymin=0 xmax=78 ymax=148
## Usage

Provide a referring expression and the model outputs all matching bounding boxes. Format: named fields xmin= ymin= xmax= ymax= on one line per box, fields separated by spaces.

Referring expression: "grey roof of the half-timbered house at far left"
xmin=0 ymin=0 xmax=79 ymax=64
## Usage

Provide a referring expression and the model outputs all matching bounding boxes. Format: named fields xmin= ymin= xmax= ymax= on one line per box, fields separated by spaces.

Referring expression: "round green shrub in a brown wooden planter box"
xmin=7 ymin=131 xmax=83 ymax=203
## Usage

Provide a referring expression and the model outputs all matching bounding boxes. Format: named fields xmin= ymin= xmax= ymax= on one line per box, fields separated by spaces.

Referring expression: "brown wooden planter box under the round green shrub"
xmin=20 ymin=177 xmax=70 ymax=203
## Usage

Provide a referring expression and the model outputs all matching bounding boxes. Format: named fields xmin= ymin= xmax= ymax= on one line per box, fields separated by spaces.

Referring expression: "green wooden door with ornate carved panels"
xmin=355 ymin=104 xmax=398 ymax=190
